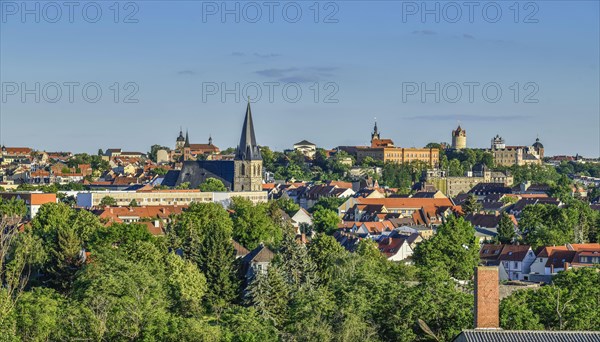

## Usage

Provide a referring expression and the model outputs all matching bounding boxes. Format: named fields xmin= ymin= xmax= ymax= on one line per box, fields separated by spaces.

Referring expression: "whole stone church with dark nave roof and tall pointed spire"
xmin=162 ymin=102 xmax=263 ymax=192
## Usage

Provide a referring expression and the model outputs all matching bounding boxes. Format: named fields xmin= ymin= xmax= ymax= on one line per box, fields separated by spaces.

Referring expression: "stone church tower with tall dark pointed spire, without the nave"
xmin=233 ymin=100 xmax=262 ymax=191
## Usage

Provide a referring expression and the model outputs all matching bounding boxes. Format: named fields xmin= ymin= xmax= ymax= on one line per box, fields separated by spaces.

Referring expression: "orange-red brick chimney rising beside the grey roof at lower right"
xmin=475 ymin=266 xmax=500 ymax=329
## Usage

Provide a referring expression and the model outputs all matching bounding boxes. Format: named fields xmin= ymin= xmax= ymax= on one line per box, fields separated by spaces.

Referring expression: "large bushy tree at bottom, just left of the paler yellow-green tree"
xmin=74 ymin=242 xmax=170 ymax=340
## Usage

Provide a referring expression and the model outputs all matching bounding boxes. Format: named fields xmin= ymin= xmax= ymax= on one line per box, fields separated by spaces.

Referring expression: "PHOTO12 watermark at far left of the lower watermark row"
xmin=2 ymin=81 xmax=140 ymax=104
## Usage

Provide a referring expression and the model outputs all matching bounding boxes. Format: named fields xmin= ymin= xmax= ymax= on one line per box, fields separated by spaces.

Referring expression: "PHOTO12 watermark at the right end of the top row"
xmin=401 ymin=1 xmax=540 ymax=24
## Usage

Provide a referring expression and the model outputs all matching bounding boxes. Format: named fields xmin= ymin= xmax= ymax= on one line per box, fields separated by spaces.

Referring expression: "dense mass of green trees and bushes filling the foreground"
xmin=0 ymin=200 xmax=600 ymax=342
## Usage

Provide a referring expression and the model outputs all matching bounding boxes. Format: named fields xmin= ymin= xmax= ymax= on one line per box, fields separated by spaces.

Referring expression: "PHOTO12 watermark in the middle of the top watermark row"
xmin=202 ymin=1 xmax=340 ymax=24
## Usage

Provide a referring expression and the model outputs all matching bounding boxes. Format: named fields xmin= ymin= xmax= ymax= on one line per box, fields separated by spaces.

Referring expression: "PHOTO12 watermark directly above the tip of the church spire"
xmin=202 ymin=82 xmax=340 ymax=104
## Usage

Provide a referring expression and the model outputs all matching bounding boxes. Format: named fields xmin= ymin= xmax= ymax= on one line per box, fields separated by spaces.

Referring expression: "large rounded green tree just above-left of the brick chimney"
xmin=413 ymin=217 xmax=479 ymax=280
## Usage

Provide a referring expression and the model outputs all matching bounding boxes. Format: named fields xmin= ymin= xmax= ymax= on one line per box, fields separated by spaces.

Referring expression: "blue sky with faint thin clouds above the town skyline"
xmin=0 ymin=0 xmax=600 ymax=157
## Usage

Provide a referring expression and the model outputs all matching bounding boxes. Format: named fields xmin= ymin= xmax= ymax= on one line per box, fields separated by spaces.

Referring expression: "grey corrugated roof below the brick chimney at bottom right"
xmin=454 ymin=330 xmax=600 ymax=342
